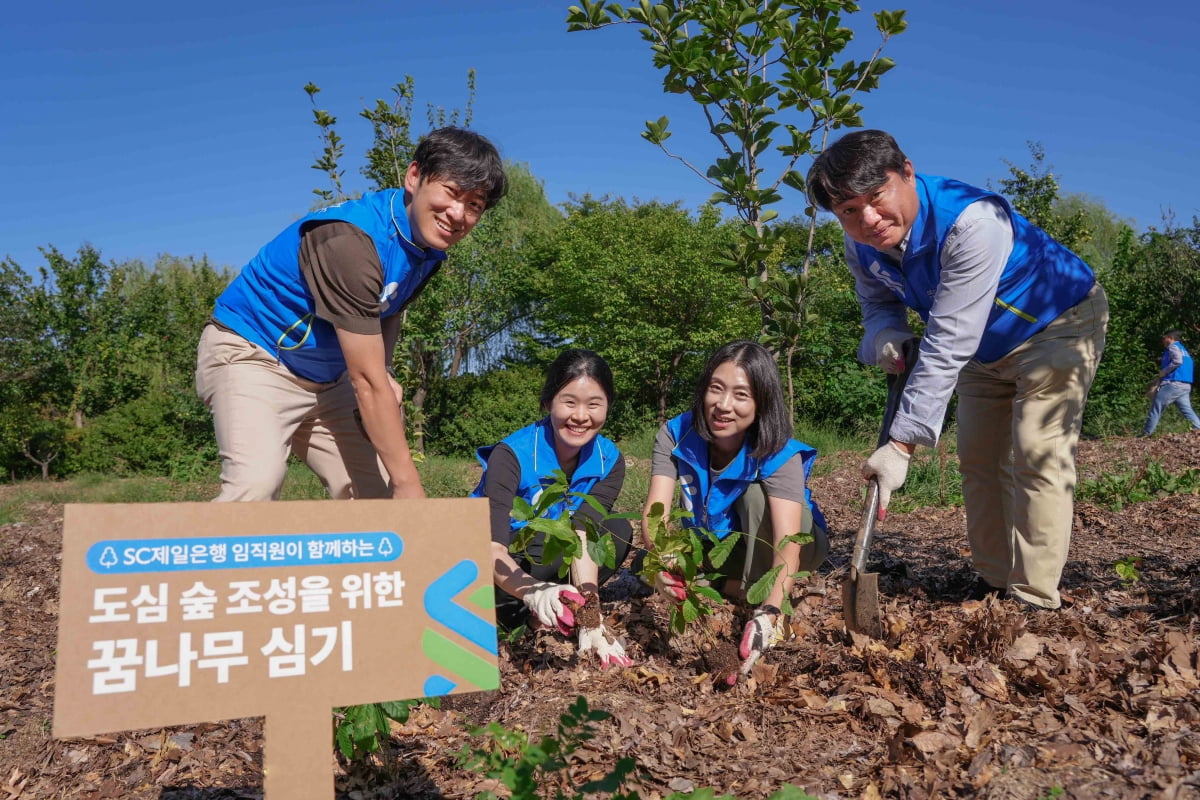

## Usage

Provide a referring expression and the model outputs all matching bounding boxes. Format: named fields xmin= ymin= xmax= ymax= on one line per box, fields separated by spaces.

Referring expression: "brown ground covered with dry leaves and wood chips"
xmin=0 ymin=434 xmax=1200 ymax=800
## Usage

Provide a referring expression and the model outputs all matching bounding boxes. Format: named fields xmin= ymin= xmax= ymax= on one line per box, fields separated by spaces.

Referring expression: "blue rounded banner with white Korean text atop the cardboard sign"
xmin=86 ymin=530 xmax=404 ymax=575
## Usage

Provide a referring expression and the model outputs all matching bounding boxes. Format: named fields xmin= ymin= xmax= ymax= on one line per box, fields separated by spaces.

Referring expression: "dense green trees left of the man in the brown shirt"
xmin=0 ymin=247 xmax=229 ymax=476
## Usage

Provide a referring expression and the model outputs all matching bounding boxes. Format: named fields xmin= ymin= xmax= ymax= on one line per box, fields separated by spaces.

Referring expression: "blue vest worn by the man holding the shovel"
xmin=854 ymin=175 xmax=1096 ymax=362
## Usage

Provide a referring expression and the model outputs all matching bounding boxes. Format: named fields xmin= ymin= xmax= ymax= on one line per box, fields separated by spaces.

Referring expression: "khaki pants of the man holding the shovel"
xmin=958 ymin=284 xmax=1109 ymax=608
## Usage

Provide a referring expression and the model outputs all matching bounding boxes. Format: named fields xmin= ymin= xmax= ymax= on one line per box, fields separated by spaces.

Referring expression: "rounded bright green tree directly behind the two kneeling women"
xmin=538 ymin=197 xmax=756 ymax=432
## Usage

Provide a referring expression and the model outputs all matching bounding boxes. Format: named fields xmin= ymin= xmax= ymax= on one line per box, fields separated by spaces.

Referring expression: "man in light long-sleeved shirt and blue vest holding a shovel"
xmin=808 ymin=131 xmax=1109 ymax=608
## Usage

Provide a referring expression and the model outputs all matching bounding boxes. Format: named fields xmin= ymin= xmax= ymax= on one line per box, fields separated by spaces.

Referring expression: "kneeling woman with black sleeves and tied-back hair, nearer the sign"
xmin=472 ymin=349 xmax=632 ymax=669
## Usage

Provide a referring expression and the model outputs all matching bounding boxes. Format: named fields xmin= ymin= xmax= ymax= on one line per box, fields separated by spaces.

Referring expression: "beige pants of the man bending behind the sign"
xmin=196 ymin=325 xmax=391 ymax=501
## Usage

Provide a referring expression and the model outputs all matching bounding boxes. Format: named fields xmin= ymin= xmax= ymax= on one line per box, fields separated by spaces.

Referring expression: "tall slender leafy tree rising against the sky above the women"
xmin=566 ymin=0 xmax=907 ymax=342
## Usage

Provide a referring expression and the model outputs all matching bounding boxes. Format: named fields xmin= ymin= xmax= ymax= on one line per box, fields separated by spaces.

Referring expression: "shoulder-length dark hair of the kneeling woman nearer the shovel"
xmin=691 ymin=339 xmax=793 ymax=458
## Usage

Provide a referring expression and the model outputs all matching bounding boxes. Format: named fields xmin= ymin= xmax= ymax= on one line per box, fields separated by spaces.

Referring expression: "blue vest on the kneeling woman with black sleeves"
xmin=470 ymin=417 xmax=620 ymax=530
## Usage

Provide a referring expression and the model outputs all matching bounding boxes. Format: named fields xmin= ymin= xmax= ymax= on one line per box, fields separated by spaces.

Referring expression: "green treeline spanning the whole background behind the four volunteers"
xmin=0 ymin=170 xmax=1200 ymax=479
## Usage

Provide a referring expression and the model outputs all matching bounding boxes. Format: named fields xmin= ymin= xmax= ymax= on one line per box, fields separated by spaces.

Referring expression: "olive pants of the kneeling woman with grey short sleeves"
xmin=725 ymin=483 xmax=829 ymax=597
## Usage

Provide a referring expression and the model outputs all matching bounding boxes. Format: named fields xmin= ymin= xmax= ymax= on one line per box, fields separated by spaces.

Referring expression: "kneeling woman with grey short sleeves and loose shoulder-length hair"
xmin=642 ymin=342 xmax=829 ymax=682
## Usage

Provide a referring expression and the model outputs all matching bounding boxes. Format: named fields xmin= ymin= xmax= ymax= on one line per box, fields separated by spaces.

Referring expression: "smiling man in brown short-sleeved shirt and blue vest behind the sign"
xmin=196 ymin=127 xmax=506 ymax=500
